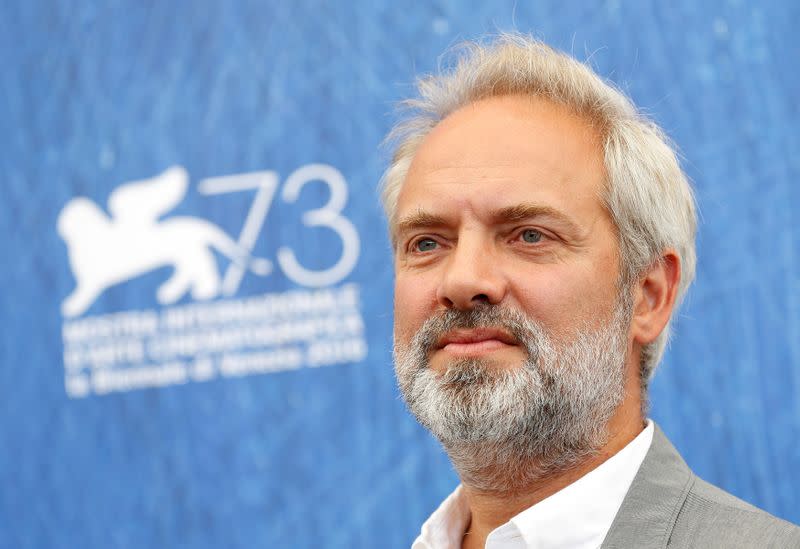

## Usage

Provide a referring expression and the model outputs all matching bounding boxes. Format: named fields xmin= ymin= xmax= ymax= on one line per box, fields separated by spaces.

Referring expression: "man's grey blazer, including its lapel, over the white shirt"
xmin=602 ymin=425 xmax=800 ymax=549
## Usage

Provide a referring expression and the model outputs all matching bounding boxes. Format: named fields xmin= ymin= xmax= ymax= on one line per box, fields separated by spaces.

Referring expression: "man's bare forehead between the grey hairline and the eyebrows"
xmin=394 ymin=96 xmax=605 ymax=229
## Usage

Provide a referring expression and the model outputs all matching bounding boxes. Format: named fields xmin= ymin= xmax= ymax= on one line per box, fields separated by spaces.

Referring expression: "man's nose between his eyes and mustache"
xmin=436 ymin=239 xmax=507 ymax=310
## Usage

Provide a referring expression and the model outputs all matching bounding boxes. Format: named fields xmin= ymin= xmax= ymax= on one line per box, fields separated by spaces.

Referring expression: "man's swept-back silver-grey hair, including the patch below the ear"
xmin=381 ymin=34 xmax=697 ymax=391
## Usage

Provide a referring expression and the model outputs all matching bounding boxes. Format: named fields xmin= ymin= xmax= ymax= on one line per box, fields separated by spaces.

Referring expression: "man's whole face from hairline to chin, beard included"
xmin=393 ymin=97 xmax=631 ymax=491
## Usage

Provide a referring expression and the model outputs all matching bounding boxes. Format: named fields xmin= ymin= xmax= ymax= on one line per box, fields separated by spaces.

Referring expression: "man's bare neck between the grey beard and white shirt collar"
xmin=454 ymin=416 xmax=644 ymax=549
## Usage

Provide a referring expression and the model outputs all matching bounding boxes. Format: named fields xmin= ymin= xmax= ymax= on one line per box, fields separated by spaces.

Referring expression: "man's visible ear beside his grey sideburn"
xmin=631 ymin=249 xmax=681 ymax=346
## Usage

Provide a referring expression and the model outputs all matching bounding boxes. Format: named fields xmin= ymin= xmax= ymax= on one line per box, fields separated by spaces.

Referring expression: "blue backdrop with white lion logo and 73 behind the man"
xmin=0 ymin=0 xmax=800 ymax=548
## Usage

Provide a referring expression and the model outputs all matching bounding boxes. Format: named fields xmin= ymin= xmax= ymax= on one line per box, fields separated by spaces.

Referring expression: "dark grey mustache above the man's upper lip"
xmin=412 ymin=304 xmax=547 ymax=360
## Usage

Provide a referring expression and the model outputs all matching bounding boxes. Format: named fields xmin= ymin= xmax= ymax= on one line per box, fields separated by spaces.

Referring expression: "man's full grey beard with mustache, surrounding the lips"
xmin=394 ymin=302 xmax=631 ymax=493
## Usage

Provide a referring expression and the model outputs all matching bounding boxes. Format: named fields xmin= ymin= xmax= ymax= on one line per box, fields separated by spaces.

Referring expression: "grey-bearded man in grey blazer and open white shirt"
xmin=383 ymin=35 xmax=800 ymax=549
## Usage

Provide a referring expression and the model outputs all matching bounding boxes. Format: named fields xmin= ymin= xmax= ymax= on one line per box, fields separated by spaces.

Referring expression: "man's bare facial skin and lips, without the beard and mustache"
xmin=392 ymin=96 xmax=619 ymax=373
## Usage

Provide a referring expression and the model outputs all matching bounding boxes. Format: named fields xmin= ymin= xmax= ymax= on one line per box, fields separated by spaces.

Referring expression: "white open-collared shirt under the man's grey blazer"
xmin=412 ymin=420 xmax=654 ymax=549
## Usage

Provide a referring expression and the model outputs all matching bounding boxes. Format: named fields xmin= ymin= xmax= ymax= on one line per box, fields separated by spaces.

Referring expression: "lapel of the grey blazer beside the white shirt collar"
xmin=602 ymin=425 xmax=694 ymax=549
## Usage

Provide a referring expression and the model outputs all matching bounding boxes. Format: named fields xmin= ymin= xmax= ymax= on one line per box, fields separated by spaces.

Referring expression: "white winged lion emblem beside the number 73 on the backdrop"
xmin=57 ymin=166 xmax=272 ymax=317
